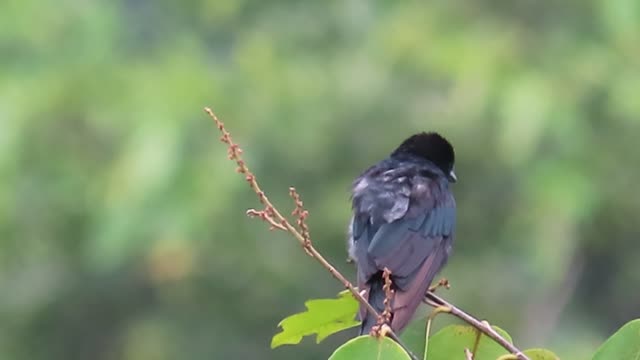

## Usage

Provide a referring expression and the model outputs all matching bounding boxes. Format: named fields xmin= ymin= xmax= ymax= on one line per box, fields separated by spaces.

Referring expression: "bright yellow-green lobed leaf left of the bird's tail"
xmin=271 ymin=290 xmax=360 ymax=349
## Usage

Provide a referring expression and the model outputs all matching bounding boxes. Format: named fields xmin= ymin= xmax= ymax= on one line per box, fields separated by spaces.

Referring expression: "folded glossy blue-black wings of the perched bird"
xmin=352 ymin=175 xmax=455 ymax=329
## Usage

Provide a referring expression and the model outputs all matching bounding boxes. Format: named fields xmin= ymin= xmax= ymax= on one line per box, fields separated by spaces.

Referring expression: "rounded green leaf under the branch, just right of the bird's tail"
xmin=428 ymin=325 xmax=511 ymax=360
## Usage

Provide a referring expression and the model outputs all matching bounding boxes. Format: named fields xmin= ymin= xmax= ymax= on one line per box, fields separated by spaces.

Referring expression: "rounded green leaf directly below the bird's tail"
xmin=329 ymin=335 xmax=411 ymax=360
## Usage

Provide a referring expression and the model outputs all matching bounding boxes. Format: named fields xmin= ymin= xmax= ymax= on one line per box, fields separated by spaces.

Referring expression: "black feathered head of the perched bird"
xmin=391 ymin=132 xmax=458 ymax=182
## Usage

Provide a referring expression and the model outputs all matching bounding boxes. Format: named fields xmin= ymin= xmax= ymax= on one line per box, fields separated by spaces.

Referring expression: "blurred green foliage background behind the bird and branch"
xmin=0 ymin=0 xmax=640 ymax=360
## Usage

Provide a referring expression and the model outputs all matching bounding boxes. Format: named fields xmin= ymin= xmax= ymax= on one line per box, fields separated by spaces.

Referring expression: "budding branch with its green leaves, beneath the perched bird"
xmin=204 ymin=108 xmax=640 ymax=360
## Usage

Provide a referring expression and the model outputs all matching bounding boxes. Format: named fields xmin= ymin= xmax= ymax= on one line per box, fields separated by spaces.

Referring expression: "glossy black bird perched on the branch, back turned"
xmin=349 ymin=132 xmax=456 ymax=334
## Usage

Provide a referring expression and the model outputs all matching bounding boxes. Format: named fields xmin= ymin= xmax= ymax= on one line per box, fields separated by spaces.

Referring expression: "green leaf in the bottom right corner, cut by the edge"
xmin=593 ymin=319 xmax=640 ymax=360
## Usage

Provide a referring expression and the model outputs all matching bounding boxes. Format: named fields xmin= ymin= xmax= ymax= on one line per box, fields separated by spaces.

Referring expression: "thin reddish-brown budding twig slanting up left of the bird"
xmin=204 ymin=107 xmax=418 ymax=360
